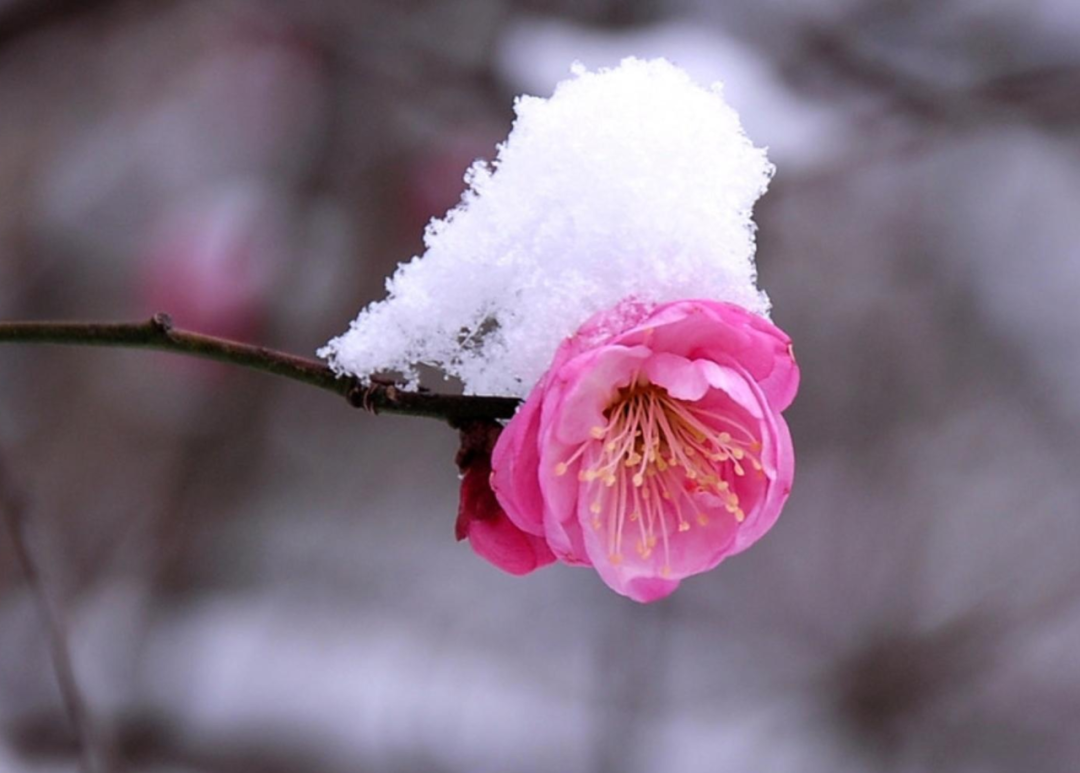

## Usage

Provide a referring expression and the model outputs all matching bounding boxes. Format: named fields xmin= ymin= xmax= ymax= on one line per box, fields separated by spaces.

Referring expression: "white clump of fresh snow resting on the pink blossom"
xmin=319 ymin=58 xmax=772 ymax=396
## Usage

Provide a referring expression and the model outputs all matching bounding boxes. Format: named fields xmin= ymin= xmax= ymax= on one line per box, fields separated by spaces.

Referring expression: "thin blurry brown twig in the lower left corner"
xmin=0 ymin=456 xmax=106 ymax=773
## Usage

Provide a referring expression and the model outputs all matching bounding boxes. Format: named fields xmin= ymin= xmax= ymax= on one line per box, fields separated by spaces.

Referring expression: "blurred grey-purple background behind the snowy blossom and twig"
xmin=0 ymin=0 xmax=1080 ymax=773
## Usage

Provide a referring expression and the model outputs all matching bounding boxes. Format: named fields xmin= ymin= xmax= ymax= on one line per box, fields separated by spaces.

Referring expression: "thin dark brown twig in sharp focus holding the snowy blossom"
xmin=0 ymin=314 xmax=518 ymax=426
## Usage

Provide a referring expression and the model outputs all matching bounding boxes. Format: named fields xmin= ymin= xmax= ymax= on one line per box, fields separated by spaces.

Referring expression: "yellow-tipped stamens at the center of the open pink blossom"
xmin=555 ymin=383 xmax=761 ymax=577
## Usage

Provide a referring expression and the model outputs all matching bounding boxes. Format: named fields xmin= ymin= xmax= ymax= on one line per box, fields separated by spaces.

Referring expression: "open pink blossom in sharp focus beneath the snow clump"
xmin=477 ymin=300 xmax=799 ymax=601
